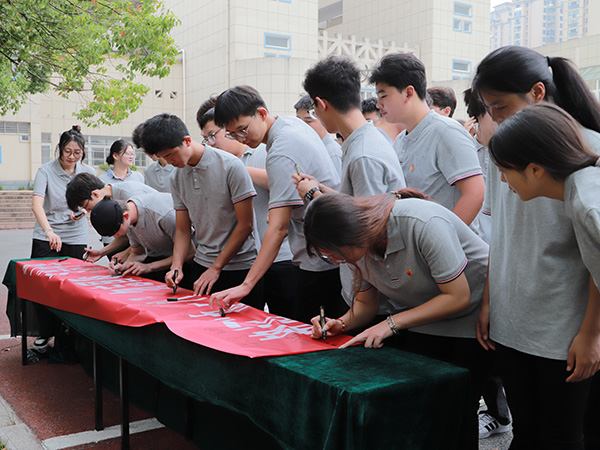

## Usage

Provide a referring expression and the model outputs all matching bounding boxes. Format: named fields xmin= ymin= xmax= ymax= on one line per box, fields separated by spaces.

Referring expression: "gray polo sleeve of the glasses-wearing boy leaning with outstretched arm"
xmin=267 ymin=155 xmax=304 ymax=209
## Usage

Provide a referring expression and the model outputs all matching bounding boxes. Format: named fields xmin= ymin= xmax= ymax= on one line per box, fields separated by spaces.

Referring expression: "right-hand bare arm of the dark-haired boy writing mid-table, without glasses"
xmin=194 ymin=198 xmax=254 ymax=295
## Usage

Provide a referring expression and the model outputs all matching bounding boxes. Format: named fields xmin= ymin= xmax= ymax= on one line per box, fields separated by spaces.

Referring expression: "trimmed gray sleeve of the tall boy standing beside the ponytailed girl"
xmin=436 ymin=123 xmax=483 ymax=185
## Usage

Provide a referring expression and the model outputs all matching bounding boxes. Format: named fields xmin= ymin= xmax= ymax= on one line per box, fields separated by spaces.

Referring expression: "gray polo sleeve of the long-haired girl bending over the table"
xmin=415 ymin=217 xmax=467 ymax=283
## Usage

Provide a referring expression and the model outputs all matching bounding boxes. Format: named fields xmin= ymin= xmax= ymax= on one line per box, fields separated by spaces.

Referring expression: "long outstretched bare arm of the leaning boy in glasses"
xmin=210 ymin=206 xmax=292 ymax=309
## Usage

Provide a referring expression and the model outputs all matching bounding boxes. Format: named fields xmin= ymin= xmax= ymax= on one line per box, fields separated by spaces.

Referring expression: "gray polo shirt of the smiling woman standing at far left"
xmin=33 ymin=159 xmax=96 ymax=245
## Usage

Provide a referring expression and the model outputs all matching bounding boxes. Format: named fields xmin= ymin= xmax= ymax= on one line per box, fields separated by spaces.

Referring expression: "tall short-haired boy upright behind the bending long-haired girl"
xmin=369 ymin=53 xmax=485 ymax=225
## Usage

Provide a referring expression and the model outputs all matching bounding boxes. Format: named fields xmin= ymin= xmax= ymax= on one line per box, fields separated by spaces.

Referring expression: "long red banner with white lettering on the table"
xmin=17 ymin=259 xmax=350 ymax=358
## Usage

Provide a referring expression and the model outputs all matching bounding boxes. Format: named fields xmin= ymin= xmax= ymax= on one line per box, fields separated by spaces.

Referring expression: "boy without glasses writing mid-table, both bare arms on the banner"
xmin=142 ymin=114 xmax=263 ymax=308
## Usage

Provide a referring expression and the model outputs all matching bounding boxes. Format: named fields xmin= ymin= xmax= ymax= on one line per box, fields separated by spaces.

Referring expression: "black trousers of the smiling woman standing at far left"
xmin=27 ymin=239 xmax=86 ymax=338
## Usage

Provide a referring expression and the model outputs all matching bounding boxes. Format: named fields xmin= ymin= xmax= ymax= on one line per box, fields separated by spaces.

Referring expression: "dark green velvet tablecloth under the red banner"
xmin=4 ymin=262 xmax=469 ymax=450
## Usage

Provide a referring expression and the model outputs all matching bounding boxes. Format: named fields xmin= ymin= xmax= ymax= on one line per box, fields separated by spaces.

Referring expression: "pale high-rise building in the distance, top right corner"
xmin=490 ymin=0 xmax=600 ymax=50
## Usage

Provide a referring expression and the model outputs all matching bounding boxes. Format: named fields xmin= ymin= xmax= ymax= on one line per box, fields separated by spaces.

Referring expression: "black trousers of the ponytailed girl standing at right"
xmin=496 ymin=344 xmax=600 ymax=450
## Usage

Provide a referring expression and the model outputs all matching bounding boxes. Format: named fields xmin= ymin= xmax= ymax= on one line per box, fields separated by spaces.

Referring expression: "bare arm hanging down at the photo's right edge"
xmin=566 ymin=277 xmax=600 ymax=383
